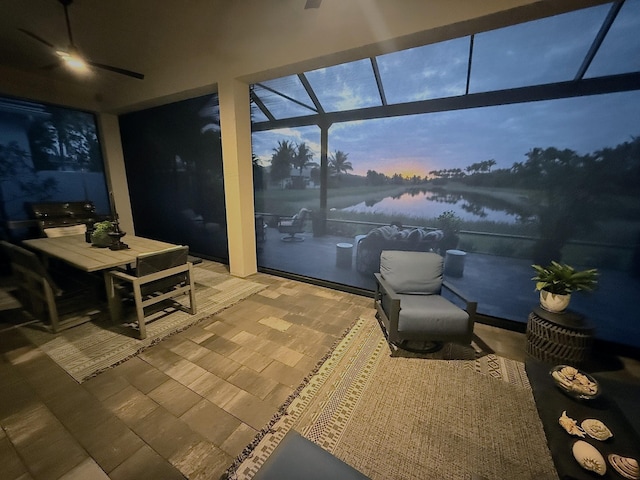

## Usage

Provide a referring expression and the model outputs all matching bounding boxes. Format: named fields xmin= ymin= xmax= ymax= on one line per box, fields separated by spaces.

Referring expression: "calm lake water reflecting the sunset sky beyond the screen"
xmin=342 ymin=189 xmax=531 ymax=224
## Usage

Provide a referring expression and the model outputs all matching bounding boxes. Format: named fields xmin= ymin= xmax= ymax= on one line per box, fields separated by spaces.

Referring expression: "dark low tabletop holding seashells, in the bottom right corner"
xmin=525 ymin=359 xmax=640 ymax=480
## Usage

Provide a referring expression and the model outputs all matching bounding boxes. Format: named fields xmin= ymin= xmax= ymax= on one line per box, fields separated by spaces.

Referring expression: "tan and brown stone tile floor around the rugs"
xmin=0 ymin=262 xmax=640 ymax=480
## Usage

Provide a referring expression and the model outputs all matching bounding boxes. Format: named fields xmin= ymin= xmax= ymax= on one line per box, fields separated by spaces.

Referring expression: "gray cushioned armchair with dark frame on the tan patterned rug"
xmin=375 ymin=250 xmax=477 ymax=352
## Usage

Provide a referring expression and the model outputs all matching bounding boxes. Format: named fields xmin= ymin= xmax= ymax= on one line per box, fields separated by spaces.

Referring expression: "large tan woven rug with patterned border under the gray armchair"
xmin=226 ymin=315 xmax=558 ymax=480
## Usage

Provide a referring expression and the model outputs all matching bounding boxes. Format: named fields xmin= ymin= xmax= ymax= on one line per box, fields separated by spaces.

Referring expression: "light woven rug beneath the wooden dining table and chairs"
xmin=20 ymin=266 xmax=266 ymax=383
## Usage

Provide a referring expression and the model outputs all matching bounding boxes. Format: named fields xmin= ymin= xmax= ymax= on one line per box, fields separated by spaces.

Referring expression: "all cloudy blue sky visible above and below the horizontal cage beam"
xmin=253 ymin=0 xmax=640 ymax=176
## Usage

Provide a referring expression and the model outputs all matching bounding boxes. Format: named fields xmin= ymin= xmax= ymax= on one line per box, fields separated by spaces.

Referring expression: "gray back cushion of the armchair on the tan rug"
xmin=380 ymin=250 xmax=444 ymax=294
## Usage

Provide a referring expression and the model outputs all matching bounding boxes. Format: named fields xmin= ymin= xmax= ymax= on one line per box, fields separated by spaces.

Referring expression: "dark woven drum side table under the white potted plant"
xmin=526 ymin=307 xmax=595 ymax=367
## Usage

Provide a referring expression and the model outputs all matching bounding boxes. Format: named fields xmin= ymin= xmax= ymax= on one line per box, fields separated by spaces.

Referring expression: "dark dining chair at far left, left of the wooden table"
xmin=0 ymin=240 xmax=101 ymax=333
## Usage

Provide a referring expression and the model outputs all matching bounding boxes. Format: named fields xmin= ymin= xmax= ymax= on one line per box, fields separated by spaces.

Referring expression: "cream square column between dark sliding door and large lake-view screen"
xmin=218 ymin=79 xmax=258 ymax=277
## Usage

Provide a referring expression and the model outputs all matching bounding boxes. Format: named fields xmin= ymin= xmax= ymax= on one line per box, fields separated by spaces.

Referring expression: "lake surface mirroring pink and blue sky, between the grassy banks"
xmin=342 ymin=190 xmax=518 ymax=223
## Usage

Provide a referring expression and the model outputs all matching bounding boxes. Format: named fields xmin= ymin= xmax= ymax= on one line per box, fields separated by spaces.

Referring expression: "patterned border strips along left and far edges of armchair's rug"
xmin=220 ymin=316 xmax=529 ymax=480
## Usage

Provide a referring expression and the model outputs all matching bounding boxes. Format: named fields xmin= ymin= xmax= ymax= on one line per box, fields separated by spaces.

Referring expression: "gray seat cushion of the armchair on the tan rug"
xmin=398 ymin=294 xmax=469 ymax=337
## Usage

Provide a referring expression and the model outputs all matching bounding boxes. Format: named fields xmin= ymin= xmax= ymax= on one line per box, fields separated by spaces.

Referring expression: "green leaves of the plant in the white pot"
xmin=531 ymin=261 xmax=598 ymax=295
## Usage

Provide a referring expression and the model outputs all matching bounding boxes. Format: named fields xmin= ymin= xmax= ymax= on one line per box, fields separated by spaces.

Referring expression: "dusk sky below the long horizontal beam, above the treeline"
xmin=253 ymin=91 xmax=640 ymax=176
